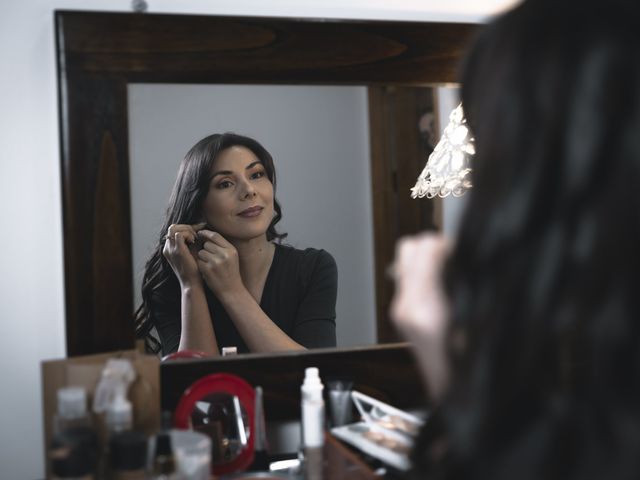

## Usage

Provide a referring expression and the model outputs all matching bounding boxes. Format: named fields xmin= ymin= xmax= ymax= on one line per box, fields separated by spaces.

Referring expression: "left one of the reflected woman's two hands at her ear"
xmin=162 ymin=223 xmax=205 ymax=287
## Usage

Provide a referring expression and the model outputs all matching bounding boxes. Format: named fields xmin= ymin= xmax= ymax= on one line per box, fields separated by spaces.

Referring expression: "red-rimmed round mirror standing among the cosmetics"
xmin=174 ymin=373 xmax=255 ymax=475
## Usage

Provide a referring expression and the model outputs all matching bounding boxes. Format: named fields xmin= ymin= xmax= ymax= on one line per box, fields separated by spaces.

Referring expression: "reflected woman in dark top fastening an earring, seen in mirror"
xmin=136 ymin=133 xmax=337 ymax=355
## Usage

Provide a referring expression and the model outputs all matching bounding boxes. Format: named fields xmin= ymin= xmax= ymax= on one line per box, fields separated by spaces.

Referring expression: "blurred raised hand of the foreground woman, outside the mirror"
xmin=391 ymin=233 xmax=449 ymax=400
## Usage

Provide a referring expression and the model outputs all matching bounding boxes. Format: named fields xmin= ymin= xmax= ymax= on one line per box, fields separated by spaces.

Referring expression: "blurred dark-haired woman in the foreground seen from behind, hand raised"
xmin=391 ymin=0 xmax=640 ymax=480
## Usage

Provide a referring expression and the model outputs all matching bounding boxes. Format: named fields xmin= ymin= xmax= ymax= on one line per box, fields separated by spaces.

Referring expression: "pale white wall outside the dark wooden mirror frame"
xmin=0 ymin=0 xmax=513 ymax=480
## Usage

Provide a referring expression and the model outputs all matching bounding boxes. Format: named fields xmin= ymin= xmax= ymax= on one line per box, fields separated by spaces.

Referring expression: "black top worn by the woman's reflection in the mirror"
xmin=151 ymin=244 xmax=338 ymax=355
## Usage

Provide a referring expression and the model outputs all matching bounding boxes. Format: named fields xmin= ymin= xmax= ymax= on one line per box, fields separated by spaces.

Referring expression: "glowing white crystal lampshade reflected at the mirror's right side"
xmin=411 ymin=104 xmax=476 ymax=198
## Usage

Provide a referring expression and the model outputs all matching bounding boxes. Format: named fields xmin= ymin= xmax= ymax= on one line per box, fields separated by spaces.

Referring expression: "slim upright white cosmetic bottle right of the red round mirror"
xmin=300 ymin=367 xmax=324 ymax=449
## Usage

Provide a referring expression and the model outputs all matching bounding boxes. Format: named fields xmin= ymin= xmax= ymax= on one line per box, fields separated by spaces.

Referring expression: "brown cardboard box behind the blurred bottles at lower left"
xmin=41 ymin=350 xmax=160 ymax=478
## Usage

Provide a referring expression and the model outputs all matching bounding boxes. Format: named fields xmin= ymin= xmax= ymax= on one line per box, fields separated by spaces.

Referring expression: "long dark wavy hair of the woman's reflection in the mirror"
xmin=135 ymin=133 xmax=287 ymax=353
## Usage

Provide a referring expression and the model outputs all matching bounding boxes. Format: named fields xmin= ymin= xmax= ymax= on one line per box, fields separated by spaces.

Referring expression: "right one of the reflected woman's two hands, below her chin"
xmin=197 ymin=230 xmax=244 ymax=300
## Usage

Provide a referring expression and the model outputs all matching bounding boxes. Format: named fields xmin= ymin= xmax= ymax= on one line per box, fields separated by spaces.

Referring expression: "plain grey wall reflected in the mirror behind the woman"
xmin=128 ymin=84 xmax=460 ymax=347
